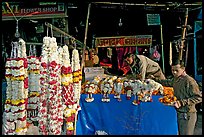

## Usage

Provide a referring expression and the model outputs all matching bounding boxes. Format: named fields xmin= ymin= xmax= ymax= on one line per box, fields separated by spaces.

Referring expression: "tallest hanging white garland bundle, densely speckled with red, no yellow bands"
xmin=39 ymin=37 xmax=63 ymax=135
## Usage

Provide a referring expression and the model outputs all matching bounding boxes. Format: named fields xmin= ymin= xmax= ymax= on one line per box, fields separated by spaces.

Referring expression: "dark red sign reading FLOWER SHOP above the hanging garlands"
xmin=2 ymin=2 xmax=65 ymax=20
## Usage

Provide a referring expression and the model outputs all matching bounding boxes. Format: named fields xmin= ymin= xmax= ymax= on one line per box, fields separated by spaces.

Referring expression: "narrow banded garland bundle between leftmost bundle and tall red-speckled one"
xmin=27 ymin=53 xmax=40 ymax=121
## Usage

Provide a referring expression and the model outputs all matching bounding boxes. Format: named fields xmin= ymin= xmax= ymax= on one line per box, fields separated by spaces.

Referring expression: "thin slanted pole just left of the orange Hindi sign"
xmin=81 ymin=3 xmax=91 ymax=70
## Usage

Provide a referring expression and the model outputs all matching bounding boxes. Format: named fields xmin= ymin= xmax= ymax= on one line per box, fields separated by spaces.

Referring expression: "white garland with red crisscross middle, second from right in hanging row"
xmin=61 ymin=45 xmax=76 ymax=135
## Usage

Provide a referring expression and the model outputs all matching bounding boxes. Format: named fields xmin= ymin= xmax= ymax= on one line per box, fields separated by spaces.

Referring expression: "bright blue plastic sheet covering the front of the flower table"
xmin=76 ymin=94 xmax=178 ymax=135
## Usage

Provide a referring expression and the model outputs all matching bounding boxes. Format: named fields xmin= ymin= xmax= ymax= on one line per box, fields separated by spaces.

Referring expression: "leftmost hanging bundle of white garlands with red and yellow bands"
xmin=3 ymin=39 xmax=28 ymax=135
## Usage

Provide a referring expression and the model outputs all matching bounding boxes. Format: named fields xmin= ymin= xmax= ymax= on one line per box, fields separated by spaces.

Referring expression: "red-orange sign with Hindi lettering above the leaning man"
xmin=95 ymin=35 xmax=152 ymax=47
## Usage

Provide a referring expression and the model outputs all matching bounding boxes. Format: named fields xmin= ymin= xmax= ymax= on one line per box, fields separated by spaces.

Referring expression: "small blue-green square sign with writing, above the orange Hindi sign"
xmin=147 ymin=14 xmax=160 ymax=25
